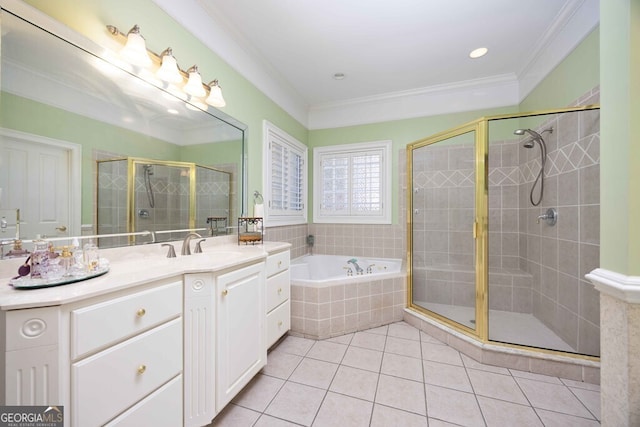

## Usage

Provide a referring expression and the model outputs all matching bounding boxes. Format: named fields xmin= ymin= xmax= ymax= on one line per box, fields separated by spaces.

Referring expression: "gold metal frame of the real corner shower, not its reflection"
xmin=406 ymin=104 xmax=600 ymax=360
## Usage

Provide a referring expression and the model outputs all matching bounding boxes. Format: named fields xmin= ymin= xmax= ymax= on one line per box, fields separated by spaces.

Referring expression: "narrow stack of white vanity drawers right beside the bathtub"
xmin=267 ymin=250 xmax=291 ymax=348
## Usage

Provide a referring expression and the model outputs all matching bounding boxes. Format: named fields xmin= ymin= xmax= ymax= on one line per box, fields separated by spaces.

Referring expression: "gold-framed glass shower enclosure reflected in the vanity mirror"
xmin=96 ymin=157 xmax=236 ymax=246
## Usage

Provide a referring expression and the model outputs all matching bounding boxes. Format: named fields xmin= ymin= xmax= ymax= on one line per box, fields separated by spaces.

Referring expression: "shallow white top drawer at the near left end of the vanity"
xmin=71 ymin=281 xmax=182 ymax=359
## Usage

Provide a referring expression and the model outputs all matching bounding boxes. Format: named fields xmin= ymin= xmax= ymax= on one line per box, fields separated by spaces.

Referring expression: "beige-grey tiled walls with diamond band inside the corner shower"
xmin=413 ymin=88 xmax=600 ymax=355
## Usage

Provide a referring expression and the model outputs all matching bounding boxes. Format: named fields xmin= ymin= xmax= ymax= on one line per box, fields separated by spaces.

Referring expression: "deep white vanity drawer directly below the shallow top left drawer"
xmin=71 ymin=319 xmax=182 ymax=426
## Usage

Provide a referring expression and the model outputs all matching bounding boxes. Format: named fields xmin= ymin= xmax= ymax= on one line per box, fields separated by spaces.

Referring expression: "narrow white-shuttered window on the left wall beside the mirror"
xmin=264 ymin=121 xmax=307 ymax=226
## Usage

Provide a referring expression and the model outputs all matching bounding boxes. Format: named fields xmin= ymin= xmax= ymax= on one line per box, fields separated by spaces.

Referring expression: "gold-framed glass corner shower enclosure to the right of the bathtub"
xmin=407 ymin=106 xmax=600 ymax=357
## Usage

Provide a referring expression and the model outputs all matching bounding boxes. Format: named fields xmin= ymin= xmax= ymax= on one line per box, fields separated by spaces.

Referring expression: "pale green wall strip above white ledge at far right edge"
xmin=600 ymin=0 xmax=640 ymax=276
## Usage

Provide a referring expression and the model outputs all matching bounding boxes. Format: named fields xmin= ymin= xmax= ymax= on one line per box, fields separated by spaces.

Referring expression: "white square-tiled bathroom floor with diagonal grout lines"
xmin=211 ymin=322 xmax=600 ymax=427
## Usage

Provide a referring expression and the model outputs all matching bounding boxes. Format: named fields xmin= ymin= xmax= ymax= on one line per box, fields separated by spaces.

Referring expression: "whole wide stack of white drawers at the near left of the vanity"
xmin=69 ymin=280 xmax=183 ymax=427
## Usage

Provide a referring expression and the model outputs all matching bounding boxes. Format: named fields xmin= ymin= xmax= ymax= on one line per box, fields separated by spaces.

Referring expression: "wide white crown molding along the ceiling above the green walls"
xmin=153 ymin=0 xmax=599 ymax=129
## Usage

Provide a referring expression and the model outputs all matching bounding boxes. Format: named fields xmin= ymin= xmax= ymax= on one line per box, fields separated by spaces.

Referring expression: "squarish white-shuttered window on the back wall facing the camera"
xmin=313 ymin=141 xmax=391 ymax=224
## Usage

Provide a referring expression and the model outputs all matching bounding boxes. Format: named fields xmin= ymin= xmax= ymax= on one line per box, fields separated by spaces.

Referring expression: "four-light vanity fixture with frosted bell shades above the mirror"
xmin=107 ymin=25 xmax=226 ymax=110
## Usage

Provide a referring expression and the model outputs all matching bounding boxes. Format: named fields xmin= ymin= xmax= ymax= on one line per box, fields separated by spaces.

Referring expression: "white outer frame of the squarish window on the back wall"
xmin=313 ymin=140 xmax=393 ymax=224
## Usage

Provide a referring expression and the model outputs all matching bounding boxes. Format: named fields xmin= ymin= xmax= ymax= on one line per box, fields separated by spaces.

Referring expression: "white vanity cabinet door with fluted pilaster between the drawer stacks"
xmin=184 ymin=262 xmax=267 ymax=426
